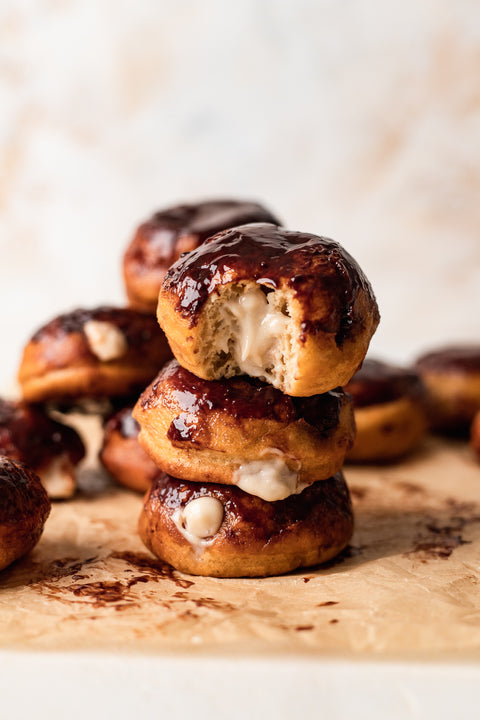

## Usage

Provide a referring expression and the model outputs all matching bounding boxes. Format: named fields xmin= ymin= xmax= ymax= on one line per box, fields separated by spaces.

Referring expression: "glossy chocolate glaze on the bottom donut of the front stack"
xmin=147 ymin=472 xmax=352 ymax=543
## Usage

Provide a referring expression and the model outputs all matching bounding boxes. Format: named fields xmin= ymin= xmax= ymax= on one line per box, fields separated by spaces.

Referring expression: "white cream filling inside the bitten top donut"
xmin=221 ymin=287 xmax=288 ymax=377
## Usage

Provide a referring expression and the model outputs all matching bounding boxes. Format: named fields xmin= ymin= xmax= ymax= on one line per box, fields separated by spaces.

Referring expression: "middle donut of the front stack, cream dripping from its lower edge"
xmin=133 ymin=360 xmax=355 ymax=501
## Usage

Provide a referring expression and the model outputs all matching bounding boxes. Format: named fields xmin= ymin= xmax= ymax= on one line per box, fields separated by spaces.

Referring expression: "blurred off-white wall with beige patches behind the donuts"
xmin=0 ymin=0 xmax=480 ymax=387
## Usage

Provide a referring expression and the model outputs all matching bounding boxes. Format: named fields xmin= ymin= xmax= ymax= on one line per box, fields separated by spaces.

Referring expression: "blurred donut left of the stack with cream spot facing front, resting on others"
xmin=18 ymin=307 xmax=171 ymax=402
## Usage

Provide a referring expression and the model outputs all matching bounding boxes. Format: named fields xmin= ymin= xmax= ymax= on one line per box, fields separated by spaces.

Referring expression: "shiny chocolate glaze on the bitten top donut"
xmin=163 ymin=223 xmax=375 ymax=346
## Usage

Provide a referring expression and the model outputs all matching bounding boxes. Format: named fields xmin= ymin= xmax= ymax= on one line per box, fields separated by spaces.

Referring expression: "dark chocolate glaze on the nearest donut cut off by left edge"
xmin=0 ymin=456 xmax=50 ymax=529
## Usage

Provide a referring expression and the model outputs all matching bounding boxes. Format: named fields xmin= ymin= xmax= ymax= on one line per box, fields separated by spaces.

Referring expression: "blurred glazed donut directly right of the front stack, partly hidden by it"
xmin=344 ymin=358 xmax=427 ymax=463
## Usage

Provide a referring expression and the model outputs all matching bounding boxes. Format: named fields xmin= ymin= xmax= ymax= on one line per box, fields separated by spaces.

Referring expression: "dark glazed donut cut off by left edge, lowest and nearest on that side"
xmin=0 ymin=456 xmax=51 ymax=570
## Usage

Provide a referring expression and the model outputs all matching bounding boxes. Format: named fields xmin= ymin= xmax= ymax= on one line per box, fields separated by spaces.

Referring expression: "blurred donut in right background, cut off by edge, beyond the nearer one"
xmin=415 ymin=345 xmax=480 ymax=436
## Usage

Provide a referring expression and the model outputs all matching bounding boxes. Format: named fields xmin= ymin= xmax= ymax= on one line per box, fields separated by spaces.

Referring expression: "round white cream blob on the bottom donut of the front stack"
xmin=173 ymin=495 xmax=224 ymax=547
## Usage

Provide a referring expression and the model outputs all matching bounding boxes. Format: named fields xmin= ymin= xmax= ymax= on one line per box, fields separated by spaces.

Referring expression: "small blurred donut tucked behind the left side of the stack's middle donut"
xmin=99 ymin=406 xmax=160 ymax=492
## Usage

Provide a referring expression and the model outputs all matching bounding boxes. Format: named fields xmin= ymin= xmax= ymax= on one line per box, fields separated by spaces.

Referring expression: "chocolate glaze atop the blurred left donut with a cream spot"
xmin=32 ymin=306 xmax=163 ymax=353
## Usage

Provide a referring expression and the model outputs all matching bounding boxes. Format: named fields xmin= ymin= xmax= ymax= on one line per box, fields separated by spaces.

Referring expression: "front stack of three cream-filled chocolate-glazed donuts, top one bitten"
xmin=133 ymin=223 xmax=379 ymax=577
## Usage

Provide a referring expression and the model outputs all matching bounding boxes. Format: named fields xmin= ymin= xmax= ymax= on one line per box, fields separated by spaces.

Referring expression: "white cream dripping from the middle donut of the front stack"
xmin=233 ymin=457 xmax=306 ymax=502
